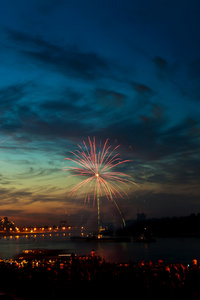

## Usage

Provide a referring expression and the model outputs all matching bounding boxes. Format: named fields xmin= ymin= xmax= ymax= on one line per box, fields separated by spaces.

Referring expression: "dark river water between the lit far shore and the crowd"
xmin=0 ymin=233 xmax=200 ymax=264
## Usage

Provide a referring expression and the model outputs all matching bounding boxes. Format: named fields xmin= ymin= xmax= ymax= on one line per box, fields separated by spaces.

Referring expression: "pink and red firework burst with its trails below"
xmin=64 ymin=137 xmax=138 ymax=227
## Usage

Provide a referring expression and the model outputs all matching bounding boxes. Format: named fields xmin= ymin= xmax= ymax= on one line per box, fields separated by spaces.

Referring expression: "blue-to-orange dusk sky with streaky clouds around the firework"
xmin=0 ymin=0 xmax=200 ymax=225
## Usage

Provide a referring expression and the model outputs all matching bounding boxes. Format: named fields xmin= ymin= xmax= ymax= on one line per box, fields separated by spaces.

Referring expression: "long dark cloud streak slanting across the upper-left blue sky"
xmin=7 ymin=29 xmax=109 ymax=80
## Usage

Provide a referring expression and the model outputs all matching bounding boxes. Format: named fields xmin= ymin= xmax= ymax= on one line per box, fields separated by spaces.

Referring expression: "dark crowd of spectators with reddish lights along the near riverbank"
xmin=0 ymin=251 xmax=200 ymax=300
